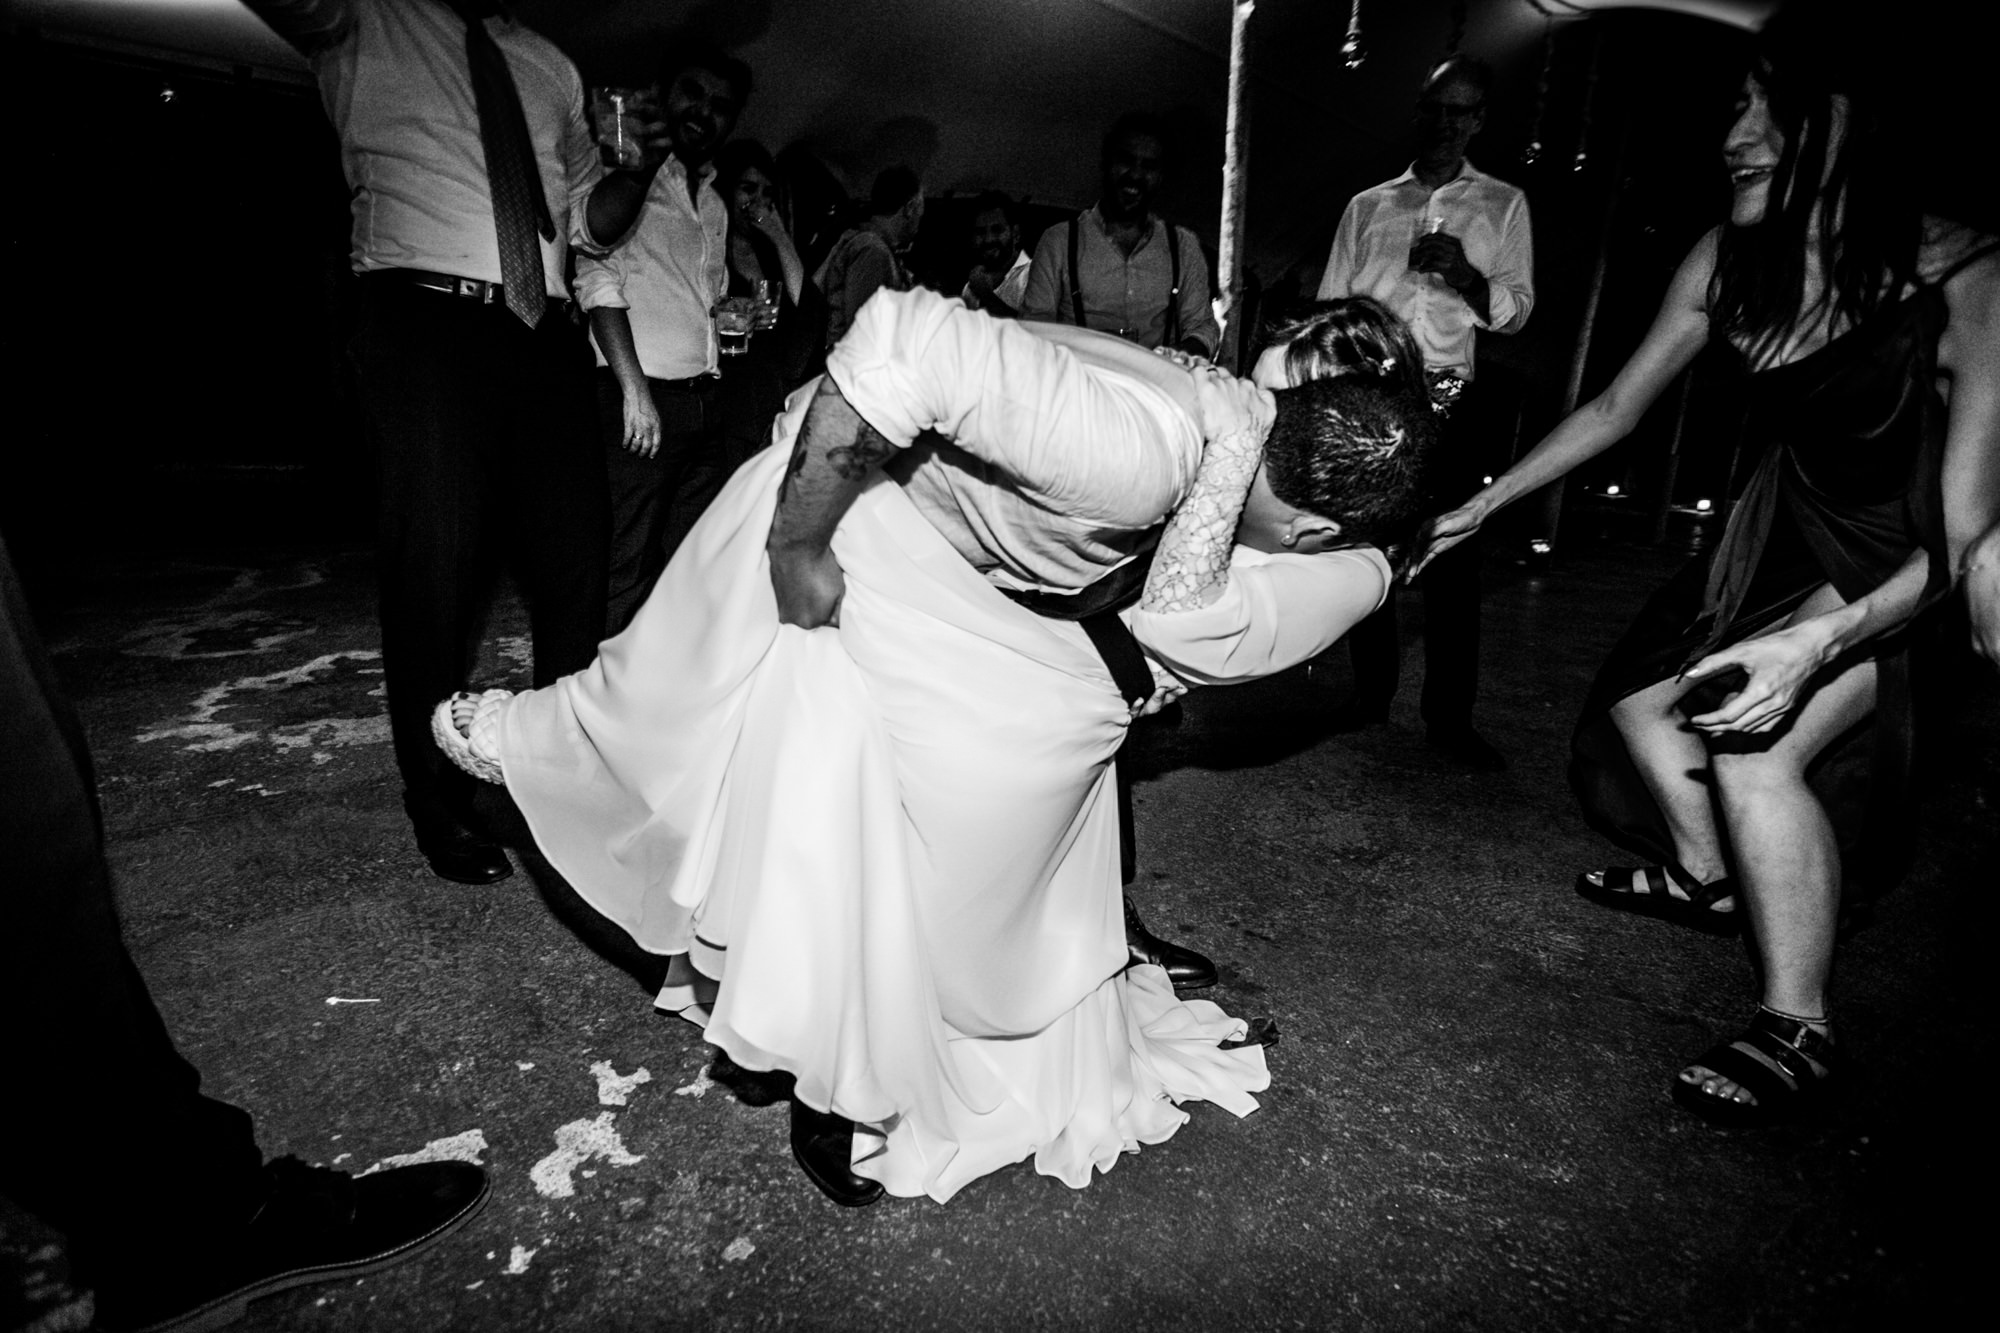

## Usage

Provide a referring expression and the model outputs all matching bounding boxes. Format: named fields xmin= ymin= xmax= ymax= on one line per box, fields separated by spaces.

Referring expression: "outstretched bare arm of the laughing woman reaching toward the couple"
xmin=1404 ymin=232 xmax=1716 ymax=578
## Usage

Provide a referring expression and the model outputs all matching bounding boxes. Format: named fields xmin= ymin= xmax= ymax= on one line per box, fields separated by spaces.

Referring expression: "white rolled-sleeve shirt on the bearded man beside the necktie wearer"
xmin=576 ymin=158 xmax=730 ymax=380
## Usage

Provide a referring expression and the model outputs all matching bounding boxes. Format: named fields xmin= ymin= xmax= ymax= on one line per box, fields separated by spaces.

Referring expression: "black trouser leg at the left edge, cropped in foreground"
xmin=0 ymin=546 xmax=264 ymax=1309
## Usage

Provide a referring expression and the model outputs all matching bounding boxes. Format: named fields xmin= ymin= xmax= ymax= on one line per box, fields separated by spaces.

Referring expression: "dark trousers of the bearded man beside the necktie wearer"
xmin=596 ymin=366 xmax=728 ymax=638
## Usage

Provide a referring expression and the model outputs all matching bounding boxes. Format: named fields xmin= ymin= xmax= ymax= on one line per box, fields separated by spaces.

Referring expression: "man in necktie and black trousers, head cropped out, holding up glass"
xmin=250 ymin=0 xmax=680 ymax=885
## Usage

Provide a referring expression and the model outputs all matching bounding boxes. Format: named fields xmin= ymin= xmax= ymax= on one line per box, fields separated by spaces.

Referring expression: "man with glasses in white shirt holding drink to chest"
xmin=1320 ymin=56 xmax=1534 ymax=771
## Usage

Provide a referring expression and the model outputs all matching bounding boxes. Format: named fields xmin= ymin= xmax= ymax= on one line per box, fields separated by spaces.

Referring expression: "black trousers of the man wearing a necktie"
xmin=354 ymin=276 xmax=606 ymax=837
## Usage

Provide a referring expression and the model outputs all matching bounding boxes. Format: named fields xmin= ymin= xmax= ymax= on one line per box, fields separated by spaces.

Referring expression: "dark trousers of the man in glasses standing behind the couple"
xmin=1348 ymin=386 xmax=1486 ymax=731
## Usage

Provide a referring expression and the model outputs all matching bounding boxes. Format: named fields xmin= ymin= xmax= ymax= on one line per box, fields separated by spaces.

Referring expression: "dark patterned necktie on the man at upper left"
xmin=452 ymin=0 xmax=556 ymax=328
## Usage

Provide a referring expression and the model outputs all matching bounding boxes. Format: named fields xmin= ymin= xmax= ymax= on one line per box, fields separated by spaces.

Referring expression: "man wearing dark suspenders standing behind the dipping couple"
xmin=1022 ymin=112 xmax=1222 ymax=356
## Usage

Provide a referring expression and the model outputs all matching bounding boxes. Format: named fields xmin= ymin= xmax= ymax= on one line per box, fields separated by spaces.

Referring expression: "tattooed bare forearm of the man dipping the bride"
xmin=766 ymin=376 xmax=896 ymax=628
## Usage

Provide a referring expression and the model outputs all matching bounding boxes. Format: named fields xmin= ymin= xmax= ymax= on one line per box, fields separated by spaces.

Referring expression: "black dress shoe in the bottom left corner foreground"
xmin=100 ymin=1157 xmax=492 ymax=1333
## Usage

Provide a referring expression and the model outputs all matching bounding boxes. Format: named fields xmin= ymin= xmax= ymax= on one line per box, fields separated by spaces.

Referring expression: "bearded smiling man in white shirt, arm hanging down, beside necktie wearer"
xmin=576 ymin=48 xmax=750 ymax=634
